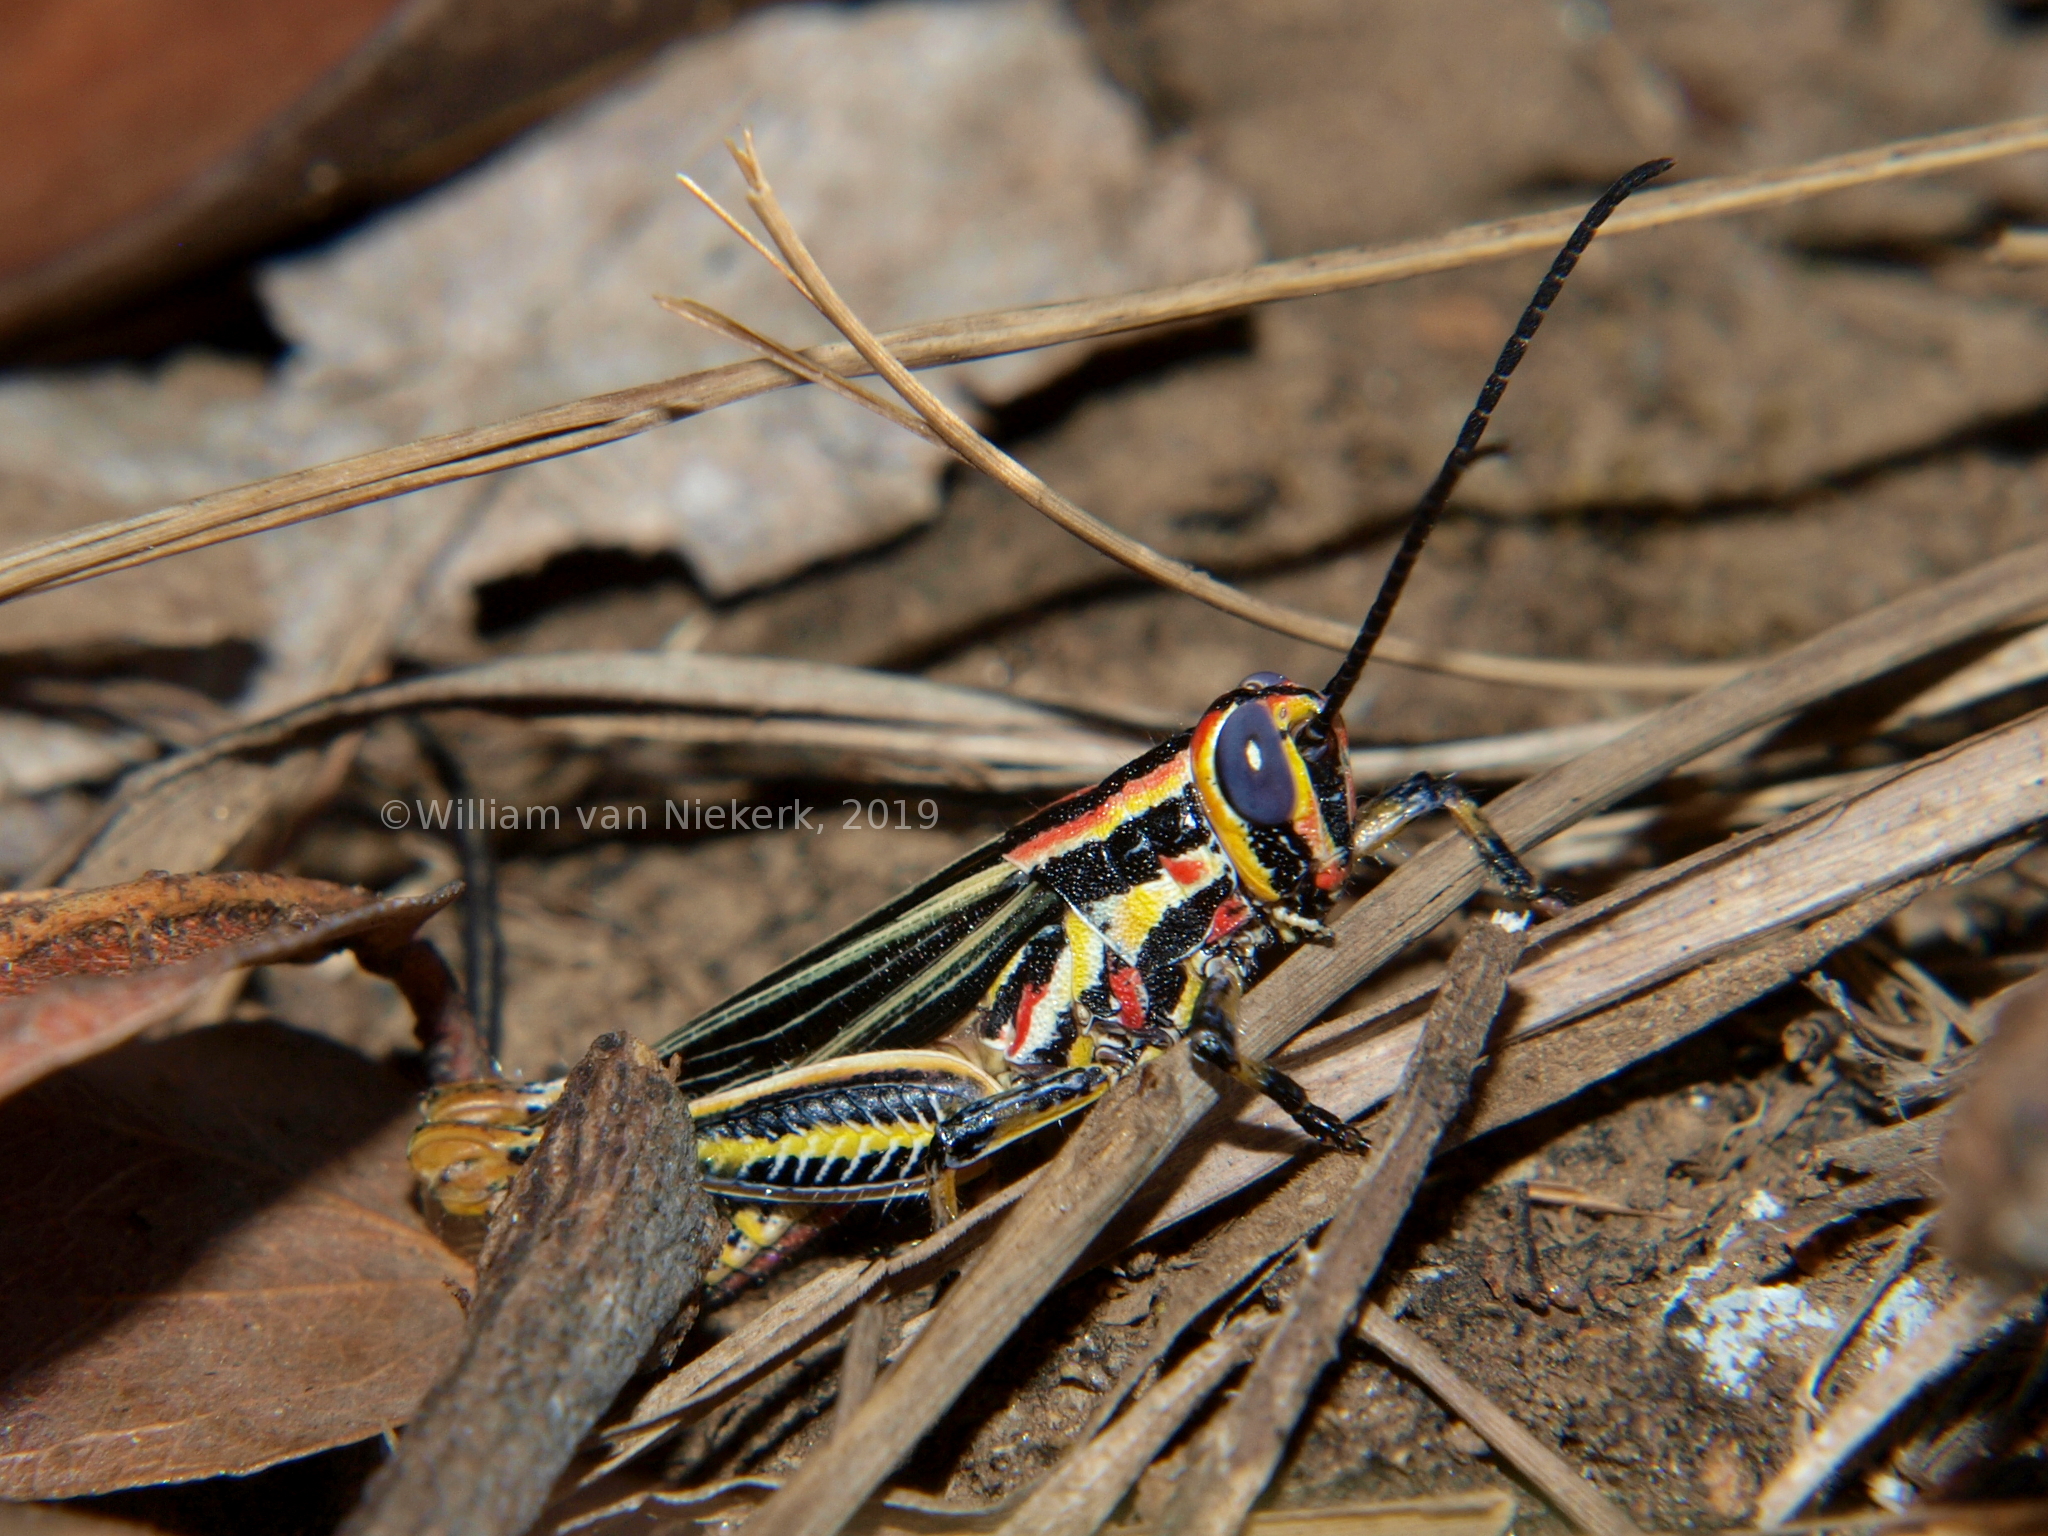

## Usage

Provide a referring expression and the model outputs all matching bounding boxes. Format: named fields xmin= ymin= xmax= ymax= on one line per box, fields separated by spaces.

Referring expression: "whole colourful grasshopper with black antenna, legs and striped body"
xmin=412 ymin=162 xmax=1669 ymax=1294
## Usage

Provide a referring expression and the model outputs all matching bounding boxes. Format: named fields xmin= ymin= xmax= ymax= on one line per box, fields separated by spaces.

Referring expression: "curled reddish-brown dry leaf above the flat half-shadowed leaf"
xmin=0 ymin=874 xmax=461 ymax=1098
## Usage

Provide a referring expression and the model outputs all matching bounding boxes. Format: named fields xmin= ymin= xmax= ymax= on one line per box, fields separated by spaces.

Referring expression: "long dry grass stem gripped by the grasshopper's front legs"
xmin=712 ymin=545 xmax=2048 ymax=1536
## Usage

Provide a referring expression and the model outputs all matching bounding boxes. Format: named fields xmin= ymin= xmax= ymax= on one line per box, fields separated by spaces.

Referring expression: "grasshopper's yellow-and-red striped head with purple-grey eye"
xmin=1188 ymin=672 xmax=1354 ymax=911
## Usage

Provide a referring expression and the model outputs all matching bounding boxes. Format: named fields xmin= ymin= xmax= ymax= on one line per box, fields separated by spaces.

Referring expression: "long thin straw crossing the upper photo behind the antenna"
xmin=0 ymin=117 xmax=2048 ymax=690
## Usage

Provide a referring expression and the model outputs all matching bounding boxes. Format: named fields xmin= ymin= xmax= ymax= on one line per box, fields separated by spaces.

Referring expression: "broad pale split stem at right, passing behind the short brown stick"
xmin=1147 ymin=715 xmax=2048 ymax=1231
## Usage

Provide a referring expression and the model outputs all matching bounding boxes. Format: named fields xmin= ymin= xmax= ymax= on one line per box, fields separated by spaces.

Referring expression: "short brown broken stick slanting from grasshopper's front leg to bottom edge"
xmin=1159 ymin=924 xmax=1531 ymax=1536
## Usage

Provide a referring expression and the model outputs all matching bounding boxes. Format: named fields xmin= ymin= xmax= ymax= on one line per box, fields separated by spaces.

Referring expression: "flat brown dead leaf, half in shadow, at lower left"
xmin=0 ymin=1024 xmax=473 ymax=1499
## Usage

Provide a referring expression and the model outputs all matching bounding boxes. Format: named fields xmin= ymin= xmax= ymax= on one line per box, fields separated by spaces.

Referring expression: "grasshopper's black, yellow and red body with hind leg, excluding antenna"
xmin=414 ymin=684 xmax=1376 ymax=1210
